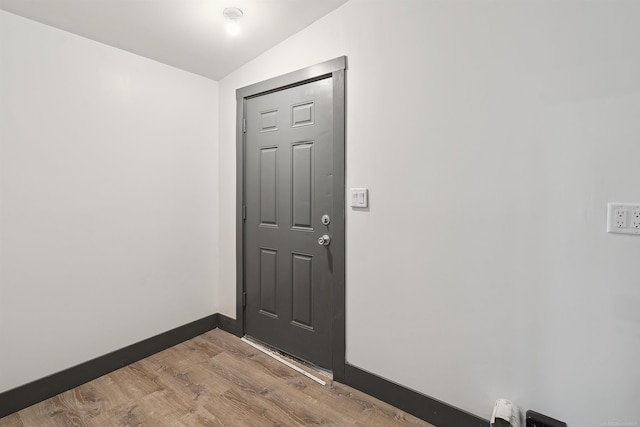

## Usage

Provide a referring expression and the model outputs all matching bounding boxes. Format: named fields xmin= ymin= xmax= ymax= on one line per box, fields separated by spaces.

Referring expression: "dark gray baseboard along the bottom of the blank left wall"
xmin=0 ymin=314 xmax=218 ymax=418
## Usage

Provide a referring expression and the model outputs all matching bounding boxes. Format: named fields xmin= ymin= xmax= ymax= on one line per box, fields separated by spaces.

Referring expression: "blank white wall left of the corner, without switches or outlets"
xmin=0 ymin=11 xmax=218 ymax=392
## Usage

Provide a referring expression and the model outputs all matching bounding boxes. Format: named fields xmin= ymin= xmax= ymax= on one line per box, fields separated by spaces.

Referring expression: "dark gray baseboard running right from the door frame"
xmin=345 ymin=364 xmax=489 ymax=427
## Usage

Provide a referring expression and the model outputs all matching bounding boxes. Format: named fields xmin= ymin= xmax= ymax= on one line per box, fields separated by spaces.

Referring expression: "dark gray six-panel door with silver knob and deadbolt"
xmin=244 ymin=76 xmax=335 ymax=369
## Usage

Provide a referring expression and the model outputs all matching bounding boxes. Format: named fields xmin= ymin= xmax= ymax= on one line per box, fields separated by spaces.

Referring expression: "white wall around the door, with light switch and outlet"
xmin=219 ymin=0 xmax=640 ymax=427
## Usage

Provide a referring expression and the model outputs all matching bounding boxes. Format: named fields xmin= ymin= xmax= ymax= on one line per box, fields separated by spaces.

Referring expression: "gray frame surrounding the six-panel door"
xmin=236 ymin=56 xmax=347 ymax=381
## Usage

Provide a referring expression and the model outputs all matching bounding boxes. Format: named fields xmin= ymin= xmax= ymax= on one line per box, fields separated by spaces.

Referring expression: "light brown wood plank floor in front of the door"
xmin=0 ymin=329 xmax=431 ymax=427
